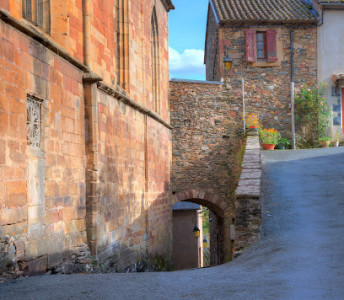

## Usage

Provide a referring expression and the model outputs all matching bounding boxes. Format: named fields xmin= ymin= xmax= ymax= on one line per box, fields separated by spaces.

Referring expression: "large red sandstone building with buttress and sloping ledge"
xmin=0 ymin=0 xmax=174 ymax=274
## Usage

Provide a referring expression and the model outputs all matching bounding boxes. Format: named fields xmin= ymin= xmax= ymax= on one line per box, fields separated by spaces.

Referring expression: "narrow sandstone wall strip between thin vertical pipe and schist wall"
xmin=147 ymin=119 xmax=172 ymax=262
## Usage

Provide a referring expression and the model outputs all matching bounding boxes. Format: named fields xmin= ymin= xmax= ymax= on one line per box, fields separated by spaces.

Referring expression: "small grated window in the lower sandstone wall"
xmin=26 ymin=96 xmax=42 ymax=149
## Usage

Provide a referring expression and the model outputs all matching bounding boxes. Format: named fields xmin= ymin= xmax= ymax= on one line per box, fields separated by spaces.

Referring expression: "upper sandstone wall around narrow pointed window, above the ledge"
xmin=129 ymin=0 xmax=169 ymax=121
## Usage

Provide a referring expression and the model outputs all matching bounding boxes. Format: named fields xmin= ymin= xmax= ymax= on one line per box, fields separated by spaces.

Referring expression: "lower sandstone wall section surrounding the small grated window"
xmin=0 ymin=21 xmax=86 ymax=273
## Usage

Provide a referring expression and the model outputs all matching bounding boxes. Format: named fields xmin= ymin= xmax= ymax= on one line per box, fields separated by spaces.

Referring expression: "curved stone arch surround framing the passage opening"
xmin=173 ymin=189 xmax=233 ymax=264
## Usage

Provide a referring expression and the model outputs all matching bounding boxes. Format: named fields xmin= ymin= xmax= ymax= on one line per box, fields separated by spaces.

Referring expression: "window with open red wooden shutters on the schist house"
xmin=246 ymin=29 xmax=277 ymax=62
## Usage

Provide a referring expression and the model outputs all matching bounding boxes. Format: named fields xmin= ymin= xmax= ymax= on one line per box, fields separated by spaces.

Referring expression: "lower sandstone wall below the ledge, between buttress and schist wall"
xmin=94 ymin=91 xmax=172 ymax=269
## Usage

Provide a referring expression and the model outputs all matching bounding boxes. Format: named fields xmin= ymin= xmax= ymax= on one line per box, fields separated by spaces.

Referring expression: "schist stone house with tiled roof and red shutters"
xmin=204 ymin=0 xmax=318 ymax=137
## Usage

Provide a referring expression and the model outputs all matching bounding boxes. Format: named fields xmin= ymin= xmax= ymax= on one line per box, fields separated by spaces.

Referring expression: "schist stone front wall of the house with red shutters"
xmin=222 ymin=27 xmax=317 ymax=137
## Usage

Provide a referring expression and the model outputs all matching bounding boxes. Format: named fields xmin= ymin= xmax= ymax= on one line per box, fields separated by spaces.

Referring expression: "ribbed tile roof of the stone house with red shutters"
xmin=210 ymin=0 xmax=317 ymax=24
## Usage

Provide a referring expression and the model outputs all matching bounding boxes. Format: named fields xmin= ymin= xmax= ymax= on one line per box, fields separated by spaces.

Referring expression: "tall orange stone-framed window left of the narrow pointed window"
xmin=115 ymin=0 xmax=129 ymax=91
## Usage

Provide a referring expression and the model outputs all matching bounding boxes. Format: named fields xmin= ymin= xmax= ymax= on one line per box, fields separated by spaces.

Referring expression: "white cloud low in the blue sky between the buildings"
xmin=169 ymin=47 xmax=205 ymax=78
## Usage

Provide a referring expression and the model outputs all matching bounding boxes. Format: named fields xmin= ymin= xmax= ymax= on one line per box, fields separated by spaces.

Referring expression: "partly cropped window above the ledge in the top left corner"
xmin=23 ymin=0 xmax=50 ymax=32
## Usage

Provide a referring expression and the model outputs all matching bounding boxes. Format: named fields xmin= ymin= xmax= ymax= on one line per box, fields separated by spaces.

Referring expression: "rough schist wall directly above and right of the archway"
xmin=170 ymin=79 xmax=243 ymax=264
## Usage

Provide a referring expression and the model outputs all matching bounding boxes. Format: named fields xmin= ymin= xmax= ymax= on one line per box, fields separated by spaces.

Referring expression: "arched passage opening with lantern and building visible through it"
xmin=173 ymin=199 xmax=225 ymax=270
